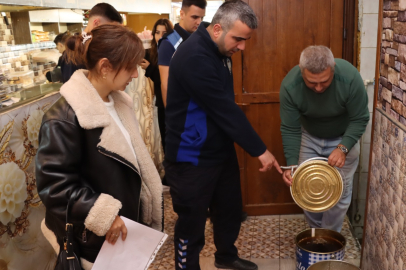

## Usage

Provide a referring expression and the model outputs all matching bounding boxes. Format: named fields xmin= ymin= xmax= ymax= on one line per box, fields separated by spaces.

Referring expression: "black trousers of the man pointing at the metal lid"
xmin=164 ymin=154 xmax=242 ymax=270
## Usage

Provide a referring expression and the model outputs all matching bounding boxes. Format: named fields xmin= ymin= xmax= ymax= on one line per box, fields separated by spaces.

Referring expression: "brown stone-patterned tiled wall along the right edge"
xmin=362 ymin=0 xmax=406 ymax=270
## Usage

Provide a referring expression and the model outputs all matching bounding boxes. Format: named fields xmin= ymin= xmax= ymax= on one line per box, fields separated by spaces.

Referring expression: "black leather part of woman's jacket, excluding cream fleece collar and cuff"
xmin=36 ymin=97 xmax=141 ymax=262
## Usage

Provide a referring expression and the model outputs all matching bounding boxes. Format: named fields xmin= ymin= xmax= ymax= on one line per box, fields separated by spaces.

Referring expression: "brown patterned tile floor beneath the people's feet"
xmin=149 ymin=193 xmax=361 ymax=270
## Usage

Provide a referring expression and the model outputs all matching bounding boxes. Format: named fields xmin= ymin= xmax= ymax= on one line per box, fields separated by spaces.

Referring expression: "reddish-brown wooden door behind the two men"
xmin=233 ymin=0 xmax=345 ymax=215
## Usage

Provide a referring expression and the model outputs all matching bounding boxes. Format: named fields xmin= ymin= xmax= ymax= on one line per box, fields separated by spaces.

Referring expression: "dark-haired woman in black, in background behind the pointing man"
xmin=141 ymin=19 xmax=173 ymax=155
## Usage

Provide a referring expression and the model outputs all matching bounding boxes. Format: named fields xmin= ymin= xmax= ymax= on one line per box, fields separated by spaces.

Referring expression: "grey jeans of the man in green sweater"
xmin=299 ymin=129 xmax=360 ymax=232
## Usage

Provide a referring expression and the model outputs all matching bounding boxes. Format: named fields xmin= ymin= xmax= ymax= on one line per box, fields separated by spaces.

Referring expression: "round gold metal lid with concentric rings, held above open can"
xmin=290 ymin=158 xmax=343 ymax=213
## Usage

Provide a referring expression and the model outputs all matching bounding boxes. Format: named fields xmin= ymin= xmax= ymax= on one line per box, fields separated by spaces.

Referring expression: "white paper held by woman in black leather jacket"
xmin=92 ymin=217 xmax=168 ymax=270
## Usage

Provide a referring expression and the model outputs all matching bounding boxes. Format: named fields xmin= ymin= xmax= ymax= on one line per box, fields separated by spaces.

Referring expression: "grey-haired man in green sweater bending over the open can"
xmin=280 ymin=46 xmax=369 ymax=232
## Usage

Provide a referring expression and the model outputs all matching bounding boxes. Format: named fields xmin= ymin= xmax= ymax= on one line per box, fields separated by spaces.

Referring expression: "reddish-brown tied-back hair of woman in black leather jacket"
xmin=66 ymin=24 xmax=145 ymax=77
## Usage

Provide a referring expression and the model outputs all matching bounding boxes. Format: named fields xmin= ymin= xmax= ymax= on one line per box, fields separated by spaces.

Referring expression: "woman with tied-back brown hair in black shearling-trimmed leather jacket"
xmin=35 ymin=24 xmax=162 ymax=270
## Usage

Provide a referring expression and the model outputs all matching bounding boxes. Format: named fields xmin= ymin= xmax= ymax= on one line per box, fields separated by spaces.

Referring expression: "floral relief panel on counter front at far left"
xmin=0 ymin=93 xmax=60 ymax=270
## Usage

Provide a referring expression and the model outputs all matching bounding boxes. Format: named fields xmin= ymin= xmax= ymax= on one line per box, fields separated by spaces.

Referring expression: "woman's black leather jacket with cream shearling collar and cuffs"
xmin=36 ymin=70 xmax=162 ymax=262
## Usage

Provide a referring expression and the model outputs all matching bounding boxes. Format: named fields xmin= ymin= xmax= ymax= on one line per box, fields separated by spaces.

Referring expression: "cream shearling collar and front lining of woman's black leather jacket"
xmin=60 ymin=70 xmax=162 ymax=230
